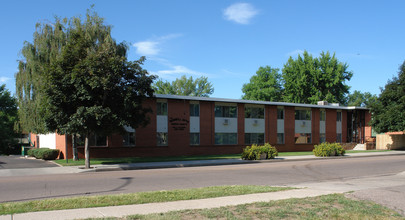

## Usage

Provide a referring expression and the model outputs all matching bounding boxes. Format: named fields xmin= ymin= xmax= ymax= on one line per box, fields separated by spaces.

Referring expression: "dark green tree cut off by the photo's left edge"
xmin=0 ymin=84 xmax=17 ymax=154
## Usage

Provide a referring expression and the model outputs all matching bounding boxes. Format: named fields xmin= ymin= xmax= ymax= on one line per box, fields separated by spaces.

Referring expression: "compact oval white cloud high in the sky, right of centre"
xmin=224 ymin=3 xmax=258 ymax=24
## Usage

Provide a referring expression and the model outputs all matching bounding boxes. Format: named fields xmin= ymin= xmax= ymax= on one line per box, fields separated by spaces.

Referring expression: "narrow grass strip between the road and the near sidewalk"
xmin=0 ymin=185 xmax=293 ymax=215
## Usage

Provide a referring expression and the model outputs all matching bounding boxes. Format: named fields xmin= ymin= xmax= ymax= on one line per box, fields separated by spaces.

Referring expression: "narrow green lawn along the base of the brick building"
xmin=55 ymin=150 xmax=388 ymax=166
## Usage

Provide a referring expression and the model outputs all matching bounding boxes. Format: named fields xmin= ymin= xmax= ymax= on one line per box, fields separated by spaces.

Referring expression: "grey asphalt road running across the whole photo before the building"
xmin=0 ymin=155 xmax=405 ymax=202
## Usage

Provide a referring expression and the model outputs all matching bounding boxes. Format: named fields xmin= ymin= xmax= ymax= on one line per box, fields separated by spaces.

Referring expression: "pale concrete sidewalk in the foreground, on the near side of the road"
xmin=0 ymin=172 xmax=405 ymax=220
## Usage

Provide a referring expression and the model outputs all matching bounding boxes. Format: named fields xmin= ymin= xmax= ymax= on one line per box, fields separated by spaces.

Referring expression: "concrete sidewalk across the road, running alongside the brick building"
xmin=0 ymin=151 xmax=405 ymax=177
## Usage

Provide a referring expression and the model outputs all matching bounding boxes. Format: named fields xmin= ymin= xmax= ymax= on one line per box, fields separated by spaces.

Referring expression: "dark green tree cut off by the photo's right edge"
xmin=370 ymin=61 xmax=405 ymax=133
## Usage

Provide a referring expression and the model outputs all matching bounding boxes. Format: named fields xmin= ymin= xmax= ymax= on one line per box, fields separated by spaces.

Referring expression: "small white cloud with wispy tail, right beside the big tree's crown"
xmin=133 ymin=34 xmax=182 ymax=56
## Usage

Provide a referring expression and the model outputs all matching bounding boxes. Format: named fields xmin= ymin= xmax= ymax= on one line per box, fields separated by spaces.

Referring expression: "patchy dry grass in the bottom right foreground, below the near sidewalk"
xmin=120 ymin=194 xmax=404 ymax=220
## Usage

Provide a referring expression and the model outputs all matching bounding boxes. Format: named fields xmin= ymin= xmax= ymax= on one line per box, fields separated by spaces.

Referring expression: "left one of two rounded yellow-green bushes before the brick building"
xmin=241 ymin=143 xmax=278 ymax=160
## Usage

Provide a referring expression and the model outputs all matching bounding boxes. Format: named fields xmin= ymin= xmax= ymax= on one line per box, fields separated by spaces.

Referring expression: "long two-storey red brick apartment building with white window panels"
xmin=31 ymin=95 xmax=371 ymax=158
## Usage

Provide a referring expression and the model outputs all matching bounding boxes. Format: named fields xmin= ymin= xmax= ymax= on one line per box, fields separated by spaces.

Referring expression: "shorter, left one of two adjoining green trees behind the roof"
xmin=242 ymin=66 xmax=283 ymax=102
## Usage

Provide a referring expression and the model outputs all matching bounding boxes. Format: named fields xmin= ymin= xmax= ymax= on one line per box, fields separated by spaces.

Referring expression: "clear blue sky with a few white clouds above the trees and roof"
xmin=0 ymin=0 xmax=405 ymax=99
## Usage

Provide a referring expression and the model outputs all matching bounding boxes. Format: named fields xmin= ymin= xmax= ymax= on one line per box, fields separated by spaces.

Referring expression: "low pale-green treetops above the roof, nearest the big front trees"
xmin=152 ymin=75 xmax=214 ymax=97
